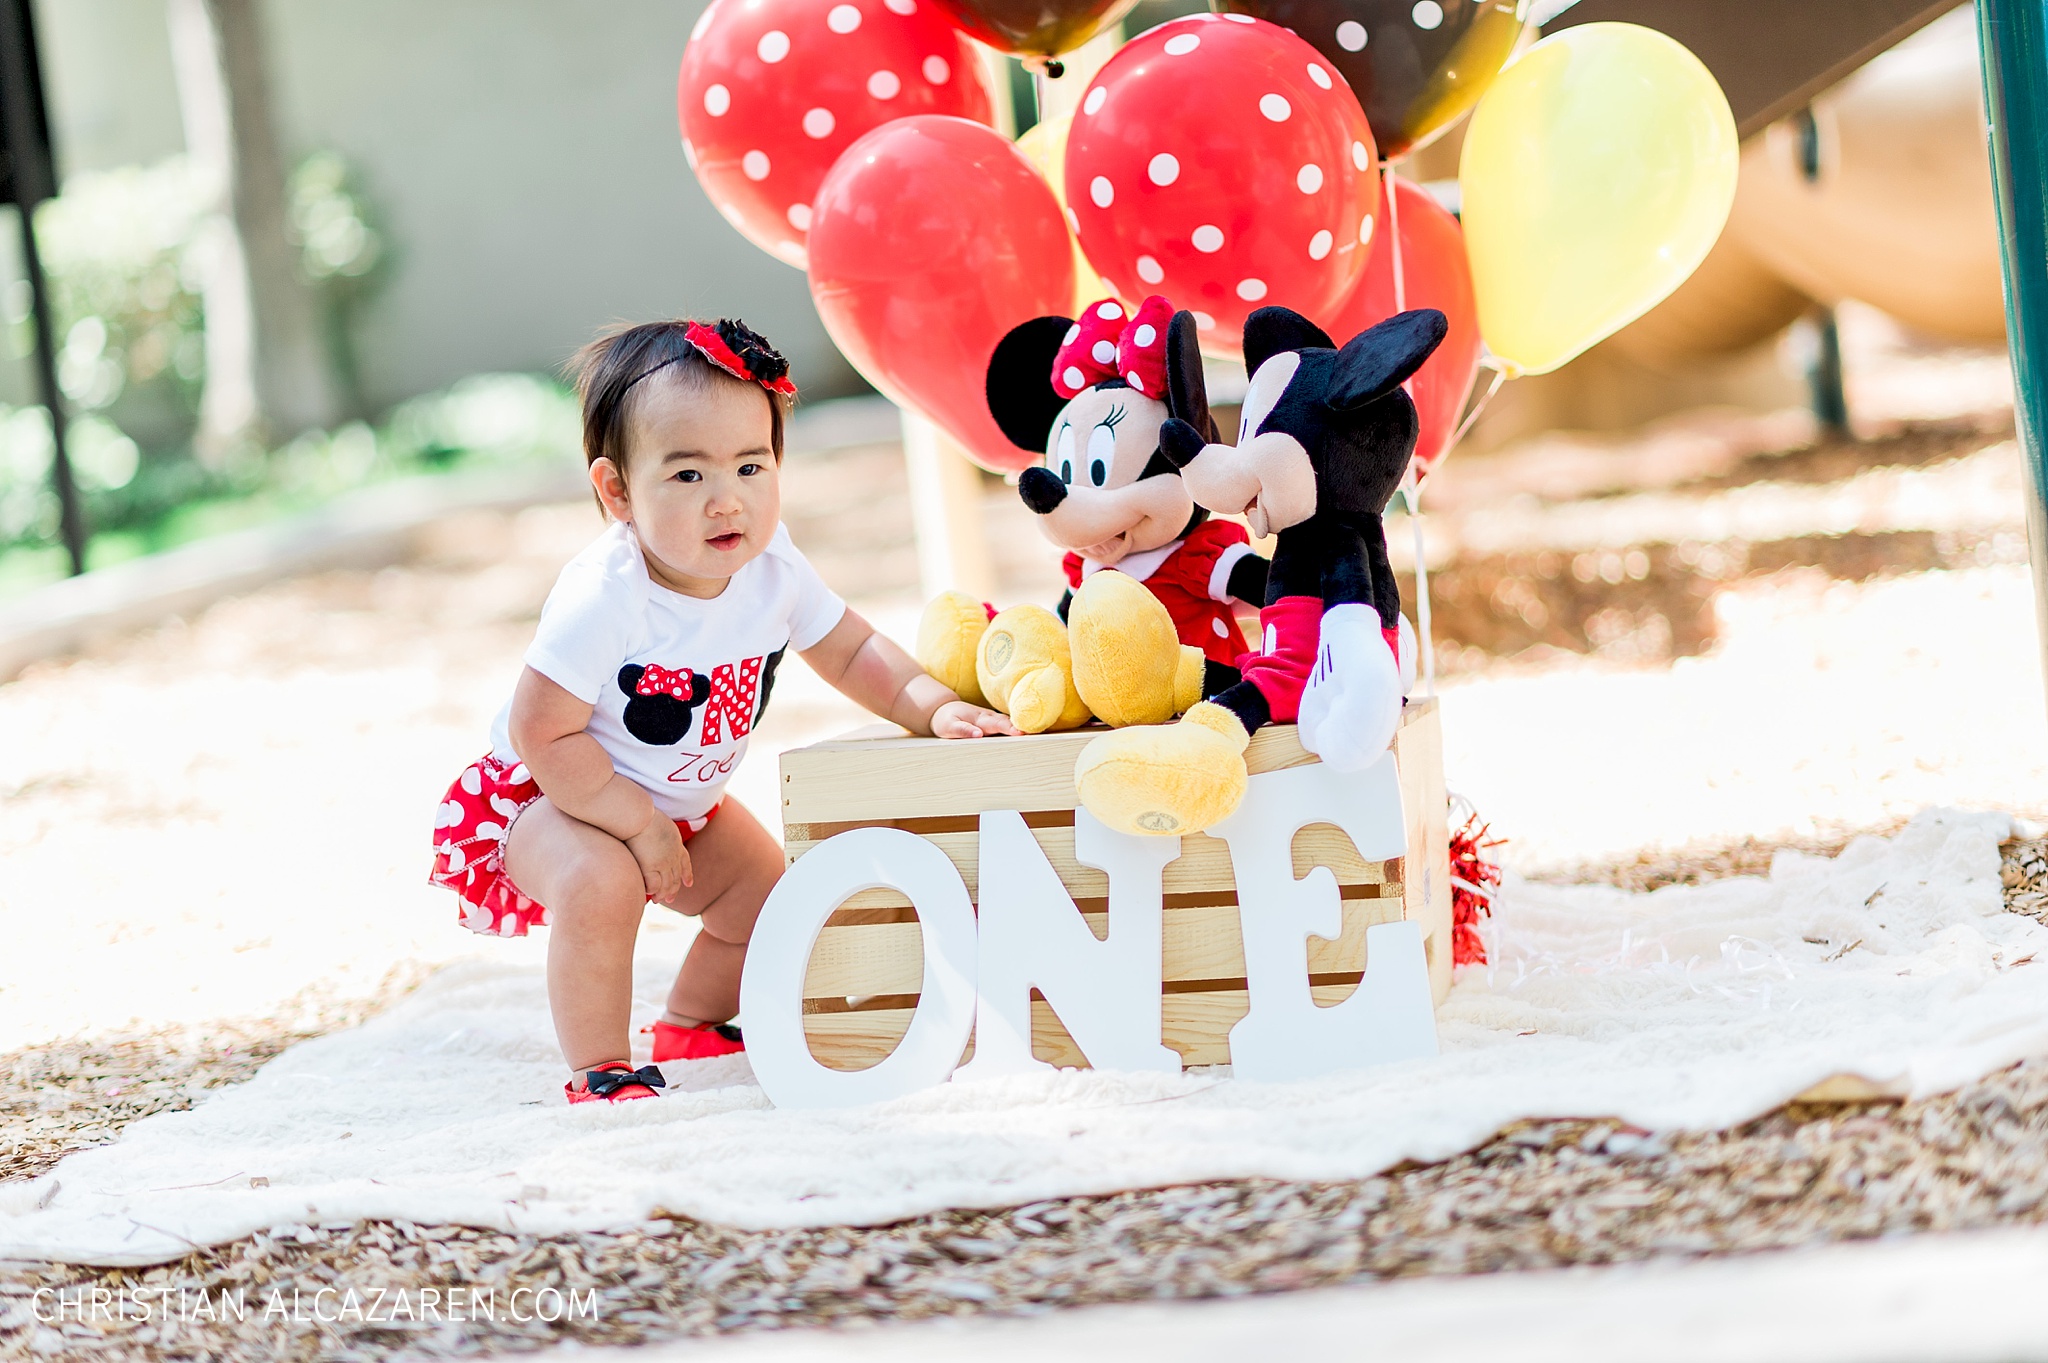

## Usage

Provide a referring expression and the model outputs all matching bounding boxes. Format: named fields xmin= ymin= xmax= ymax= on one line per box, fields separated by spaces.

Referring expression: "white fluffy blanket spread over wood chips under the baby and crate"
xmin=0 ymin=810 xmax=2048 ymax=1263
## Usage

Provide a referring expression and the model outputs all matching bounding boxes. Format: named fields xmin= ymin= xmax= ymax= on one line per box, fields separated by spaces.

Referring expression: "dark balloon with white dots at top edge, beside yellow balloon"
xmin=1210 ymin=0 xmax=1522 ymax=162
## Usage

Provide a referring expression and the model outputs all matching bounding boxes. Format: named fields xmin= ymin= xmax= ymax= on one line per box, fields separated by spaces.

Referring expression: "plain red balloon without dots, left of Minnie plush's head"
xmin=809 ymin=117 xmax=1073 ymax=473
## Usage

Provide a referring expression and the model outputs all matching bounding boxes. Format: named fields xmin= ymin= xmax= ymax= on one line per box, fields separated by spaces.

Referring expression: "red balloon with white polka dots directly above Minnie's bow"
xmin=1067 ymin=14 xmax=1380 ymax=356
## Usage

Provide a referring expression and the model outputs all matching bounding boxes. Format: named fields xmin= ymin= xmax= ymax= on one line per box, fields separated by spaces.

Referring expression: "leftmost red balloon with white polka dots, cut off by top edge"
xmin=676 ymin=0 xmax=993 ymax=270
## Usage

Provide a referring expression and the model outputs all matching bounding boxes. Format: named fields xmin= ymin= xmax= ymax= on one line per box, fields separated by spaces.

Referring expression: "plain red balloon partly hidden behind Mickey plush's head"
xmin=1317 ymin=176 xmax=1479 ymax=473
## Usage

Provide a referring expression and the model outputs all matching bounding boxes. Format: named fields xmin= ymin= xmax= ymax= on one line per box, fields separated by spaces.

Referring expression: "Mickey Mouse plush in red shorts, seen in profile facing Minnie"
xmin=1075 ymin=307 xmax=1448 ymax=835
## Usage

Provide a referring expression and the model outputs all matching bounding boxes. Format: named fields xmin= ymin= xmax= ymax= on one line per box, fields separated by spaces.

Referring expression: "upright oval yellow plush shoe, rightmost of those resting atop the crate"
xmin=1067 ymin=573 xmax=1202 ymax=729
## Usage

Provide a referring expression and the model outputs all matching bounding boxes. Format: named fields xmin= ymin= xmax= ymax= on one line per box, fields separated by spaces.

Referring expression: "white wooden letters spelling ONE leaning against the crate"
xmin=739 ymin=753 xmax=1436 ymax=1107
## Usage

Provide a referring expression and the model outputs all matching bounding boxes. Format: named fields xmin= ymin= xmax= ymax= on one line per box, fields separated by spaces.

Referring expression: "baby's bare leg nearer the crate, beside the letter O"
xmin=666 ymin=796 xmax=782 ymax=1027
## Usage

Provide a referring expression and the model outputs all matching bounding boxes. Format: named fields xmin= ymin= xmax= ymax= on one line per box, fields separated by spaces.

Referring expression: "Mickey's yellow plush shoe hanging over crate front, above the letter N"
xmin=1073 ymin=700 xmax=1251 ymax=837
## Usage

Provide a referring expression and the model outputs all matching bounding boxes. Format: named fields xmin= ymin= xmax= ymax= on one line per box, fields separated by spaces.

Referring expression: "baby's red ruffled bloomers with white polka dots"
xmin=426 ymin=757 xmax=719 ymax=937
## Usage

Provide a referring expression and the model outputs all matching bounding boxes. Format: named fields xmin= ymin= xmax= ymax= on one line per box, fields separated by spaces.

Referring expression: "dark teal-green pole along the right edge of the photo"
xmin=1976 ymin=0 xmax=2048 ymax=712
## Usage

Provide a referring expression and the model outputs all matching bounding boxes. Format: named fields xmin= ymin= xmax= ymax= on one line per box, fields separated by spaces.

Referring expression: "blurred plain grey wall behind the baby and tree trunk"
xmin=25 ymin=0 xmax=860 ymax=407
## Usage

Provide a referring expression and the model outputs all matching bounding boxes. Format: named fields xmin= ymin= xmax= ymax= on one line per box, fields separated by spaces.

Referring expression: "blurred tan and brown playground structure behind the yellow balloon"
xmin=1546 ymin=0 xmax=2005 ymax=366
